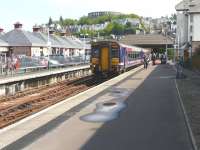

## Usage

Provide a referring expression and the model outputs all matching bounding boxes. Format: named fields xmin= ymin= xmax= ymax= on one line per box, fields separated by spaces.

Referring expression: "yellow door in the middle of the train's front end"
xmin=101 ymin=47 xmax=109 ymax=71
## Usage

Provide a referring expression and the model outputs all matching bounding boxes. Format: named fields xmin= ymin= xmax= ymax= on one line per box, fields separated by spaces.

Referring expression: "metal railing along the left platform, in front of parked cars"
xmin=0 ymin=55 xmax=90 ymax=77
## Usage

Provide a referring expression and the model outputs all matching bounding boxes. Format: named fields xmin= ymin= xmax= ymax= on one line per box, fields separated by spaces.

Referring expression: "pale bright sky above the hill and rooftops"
xmin=0 ymin=0 xmax=181 ymax=32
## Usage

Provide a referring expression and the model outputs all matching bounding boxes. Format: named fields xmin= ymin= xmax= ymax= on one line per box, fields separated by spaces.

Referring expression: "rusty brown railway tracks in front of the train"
xmin=0 ymin=76 xmax=106 ymax=129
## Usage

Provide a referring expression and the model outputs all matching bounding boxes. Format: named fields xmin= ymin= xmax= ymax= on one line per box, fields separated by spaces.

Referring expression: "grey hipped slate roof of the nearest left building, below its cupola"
xmin=1 ymin=29 xmax=46 ymax=46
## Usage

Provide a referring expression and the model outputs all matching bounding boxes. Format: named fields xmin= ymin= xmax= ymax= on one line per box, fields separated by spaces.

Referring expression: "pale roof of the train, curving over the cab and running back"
xmin=92 ymin=40 xmax=149 ymax=52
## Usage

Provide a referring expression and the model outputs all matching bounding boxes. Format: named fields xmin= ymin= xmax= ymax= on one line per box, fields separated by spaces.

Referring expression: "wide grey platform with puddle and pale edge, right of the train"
xmin=0 ymin=64 xmax=193 ymax=150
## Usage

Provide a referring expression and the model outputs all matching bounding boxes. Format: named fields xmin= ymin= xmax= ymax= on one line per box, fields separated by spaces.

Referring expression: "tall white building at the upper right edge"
xmin=176 ymin=0 xmax=200 ymax=55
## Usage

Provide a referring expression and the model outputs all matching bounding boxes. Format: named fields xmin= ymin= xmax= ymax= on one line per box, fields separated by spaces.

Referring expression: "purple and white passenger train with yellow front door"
xmin=90 ymin=40 xmax=150 ymax=75
